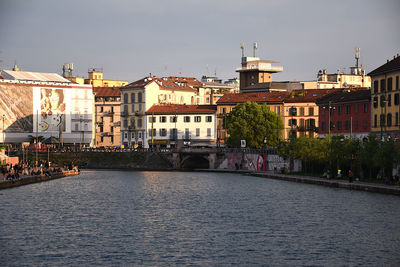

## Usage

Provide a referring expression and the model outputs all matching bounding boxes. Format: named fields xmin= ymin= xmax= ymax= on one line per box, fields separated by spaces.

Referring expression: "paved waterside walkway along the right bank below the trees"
xmin=199 ymin=169 xmax=400 ymax=196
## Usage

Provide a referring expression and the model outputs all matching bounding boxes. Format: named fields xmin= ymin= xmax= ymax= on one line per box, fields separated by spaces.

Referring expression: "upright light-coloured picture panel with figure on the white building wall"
xmin=39 ymin=88 xmax=65 ymax=132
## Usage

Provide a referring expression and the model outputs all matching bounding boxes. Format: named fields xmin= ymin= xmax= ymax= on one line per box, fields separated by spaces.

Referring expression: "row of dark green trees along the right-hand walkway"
xmin=279 ymin=135 xmax=400 ymax=179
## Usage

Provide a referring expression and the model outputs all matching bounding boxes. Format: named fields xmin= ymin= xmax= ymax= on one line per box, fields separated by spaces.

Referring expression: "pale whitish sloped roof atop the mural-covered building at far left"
xmin=2 ymin=70 xmax=71 ymax=83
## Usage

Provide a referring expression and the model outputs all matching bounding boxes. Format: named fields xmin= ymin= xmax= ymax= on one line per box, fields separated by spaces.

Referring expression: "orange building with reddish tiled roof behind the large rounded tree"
xmin=217 ymin=92 xmax=289 ymax=145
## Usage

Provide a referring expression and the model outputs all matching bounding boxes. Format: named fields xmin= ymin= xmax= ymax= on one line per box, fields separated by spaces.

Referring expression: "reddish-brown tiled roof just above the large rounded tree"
xmin=217 ymin=92 xmax=289 ymax=104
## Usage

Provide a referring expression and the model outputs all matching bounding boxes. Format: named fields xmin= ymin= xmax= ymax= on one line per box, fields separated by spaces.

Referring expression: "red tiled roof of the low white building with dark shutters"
xmin=146 ymin=105 xmax=217 ymax=114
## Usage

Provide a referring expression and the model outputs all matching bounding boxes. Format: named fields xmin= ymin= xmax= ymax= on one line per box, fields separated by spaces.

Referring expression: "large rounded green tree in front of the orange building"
xmin=226 ymin=102 xmax=283 ymax=148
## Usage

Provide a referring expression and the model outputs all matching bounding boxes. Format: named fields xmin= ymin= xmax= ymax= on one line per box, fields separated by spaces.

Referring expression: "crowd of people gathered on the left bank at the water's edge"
xmin=0 ymin=161 xmax=79 ymax=181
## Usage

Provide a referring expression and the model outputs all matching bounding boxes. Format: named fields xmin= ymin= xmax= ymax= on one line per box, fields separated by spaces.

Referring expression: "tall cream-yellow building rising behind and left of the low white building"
xmin=120 ymin=76 xmax=197 ymax=147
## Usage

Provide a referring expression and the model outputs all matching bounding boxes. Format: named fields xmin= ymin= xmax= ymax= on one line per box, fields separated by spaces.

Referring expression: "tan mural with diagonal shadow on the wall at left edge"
xmin=0 ymin=84 xmax=33 ymax=133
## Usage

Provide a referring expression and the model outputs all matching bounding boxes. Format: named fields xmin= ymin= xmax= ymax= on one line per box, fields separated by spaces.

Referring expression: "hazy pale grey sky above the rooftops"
xmin=0 ymin=0 xmax=400 ymax=82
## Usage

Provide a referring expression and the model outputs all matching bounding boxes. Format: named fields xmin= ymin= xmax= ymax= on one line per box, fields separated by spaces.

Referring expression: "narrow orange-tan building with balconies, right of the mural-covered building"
xmin=93 ymin=87 xmax=121 ymax=147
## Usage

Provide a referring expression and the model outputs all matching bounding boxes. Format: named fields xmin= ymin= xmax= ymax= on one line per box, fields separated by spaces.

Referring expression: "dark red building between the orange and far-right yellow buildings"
xmin=317 ymin=88 xmax=371 ymax=138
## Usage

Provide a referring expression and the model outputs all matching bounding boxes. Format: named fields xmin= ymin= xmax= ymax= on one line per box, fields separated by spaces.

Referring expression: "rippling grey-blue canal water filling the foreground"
xmin=0 ymin=171 xmax=400 ymax=266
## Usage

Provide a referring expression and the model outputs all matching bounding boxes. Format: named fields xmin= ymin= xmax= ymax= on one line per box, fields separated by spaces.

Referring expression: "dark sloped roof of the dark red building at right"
xmin=317 ymin=88 xmax=371 ymax=105
